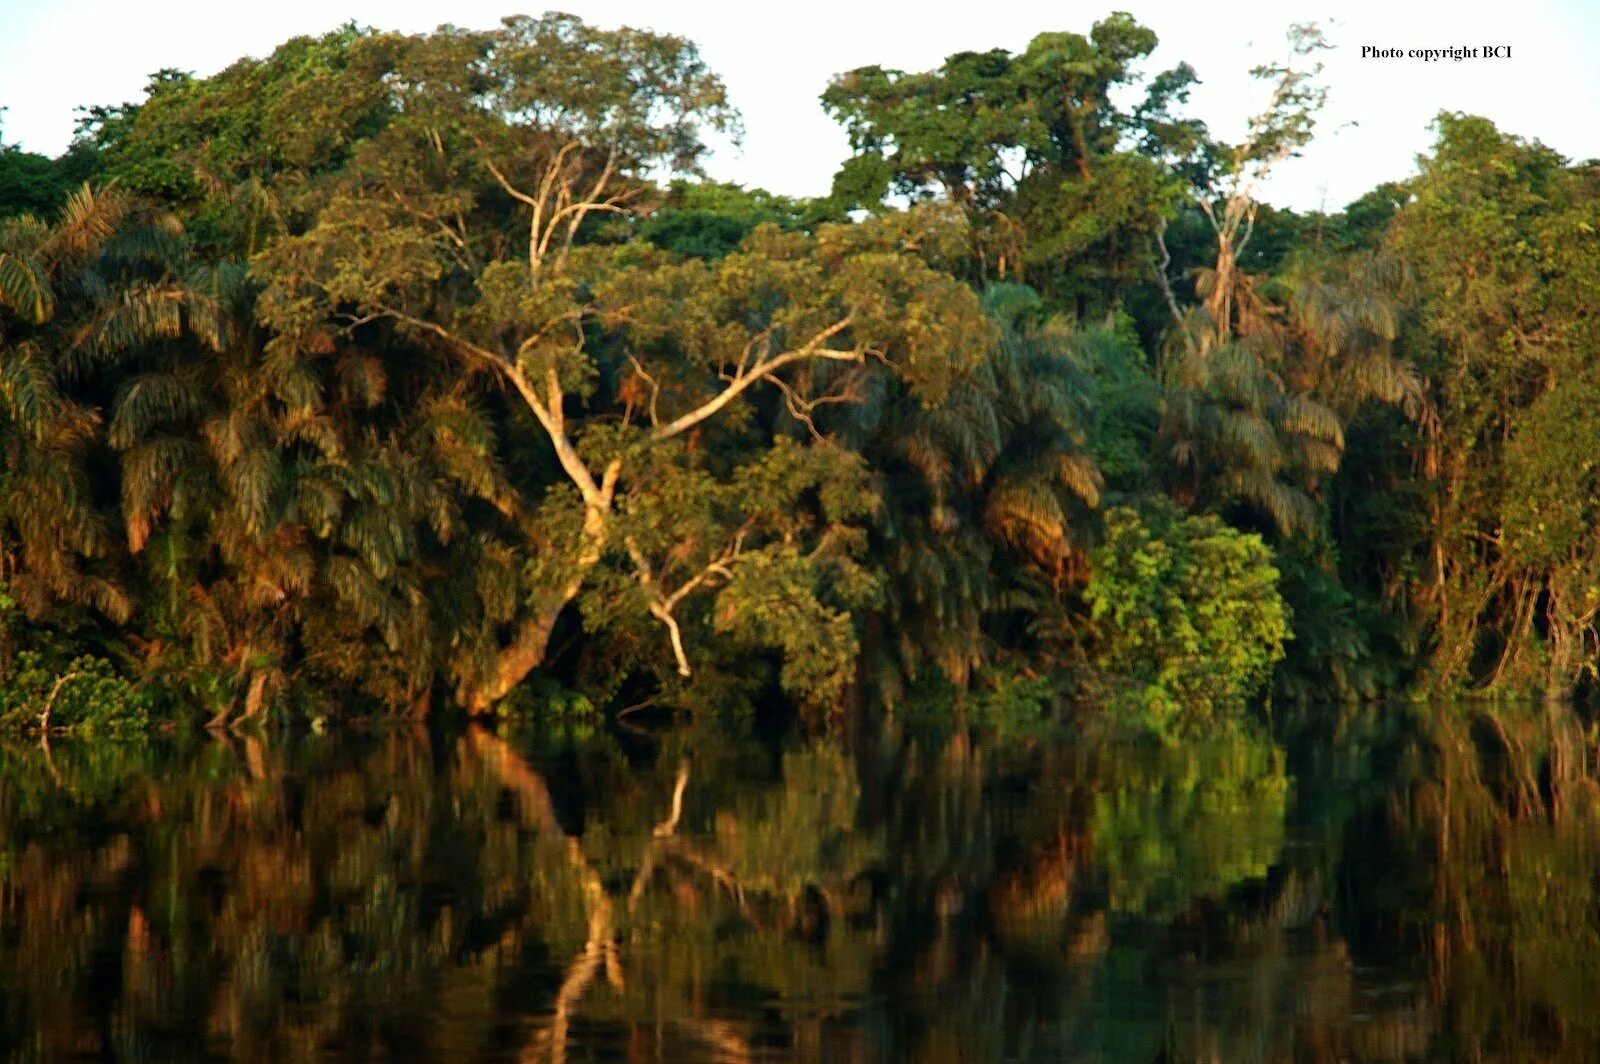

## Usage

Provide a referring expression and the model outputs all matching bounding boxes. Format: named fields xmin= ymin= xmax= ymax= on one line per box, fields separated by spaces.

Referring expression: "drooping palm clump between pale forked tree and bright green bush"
xmin=846 ymin=285 xmax=1101 ymax=699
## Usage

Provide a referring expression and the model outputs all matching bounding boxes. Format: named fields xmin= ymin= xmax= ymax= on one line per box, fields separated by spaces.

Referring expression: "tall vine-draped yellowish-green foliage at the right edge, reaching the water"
xmin=1386 ymin=114 xmax=1600 ymax=696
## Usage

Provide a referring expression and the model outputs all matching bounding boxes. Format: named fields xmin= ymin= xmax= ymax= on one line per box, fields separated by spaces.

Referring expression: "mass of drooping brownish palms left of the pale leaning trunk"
xmin=0 ymin=187 xmax=518 ymax=720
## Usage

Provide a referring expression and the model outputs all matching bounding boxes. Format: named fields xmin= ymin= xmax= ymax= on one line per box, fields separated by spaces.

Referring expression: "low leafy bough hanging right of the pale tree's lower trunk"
xmin=581 ymin=438 xmax=877 ymax=706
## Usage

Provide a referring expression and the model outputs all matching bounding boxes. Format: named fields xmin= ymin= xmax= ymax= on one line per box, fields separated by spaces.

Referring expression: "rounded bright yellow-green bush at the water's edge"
xmin=1085 ymin=504 xmax=1290 ymax=734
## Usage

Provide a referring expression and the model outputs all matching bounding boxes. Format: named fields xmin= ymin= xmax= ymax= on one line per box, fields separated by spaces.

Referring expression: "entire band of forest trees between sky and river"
xmin=0 ymin=14 xmax=1600 ymax=730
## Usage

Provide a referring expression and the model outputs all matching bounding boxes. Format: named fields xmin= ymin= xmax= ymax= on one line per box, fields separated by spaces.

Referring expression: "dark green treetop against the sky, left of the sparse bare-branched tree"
xmin=822 ymin=13 xmax=1203 ymax=307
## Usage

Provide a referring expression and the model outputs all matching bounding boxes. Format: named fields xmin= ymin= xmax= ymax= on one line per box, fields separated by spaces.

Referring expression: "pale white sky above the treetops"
xmin=0 ymin=0 xmax=1600 ymax=210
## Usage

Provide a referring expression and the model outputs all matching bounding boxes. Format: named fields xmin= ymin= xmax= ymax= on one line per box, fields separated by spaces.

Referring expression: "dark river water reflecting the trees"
xmin=0 ymin=709 xmax=1600 ymax=1062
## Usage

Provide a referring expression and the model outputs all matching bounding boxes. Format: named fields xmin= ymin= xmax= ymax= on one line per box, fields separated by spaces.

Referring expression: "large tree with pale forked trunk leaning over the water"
xmin=238 ymin=16 xmax=987 ymax=709
